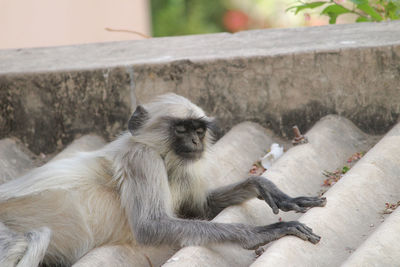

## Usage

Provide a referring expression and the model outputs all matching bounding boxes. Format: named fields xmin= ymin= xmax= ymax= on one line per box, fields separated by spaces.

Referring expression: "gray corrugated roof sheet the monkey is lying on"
xmin=0 ymin=115 xmax=400 ymax=267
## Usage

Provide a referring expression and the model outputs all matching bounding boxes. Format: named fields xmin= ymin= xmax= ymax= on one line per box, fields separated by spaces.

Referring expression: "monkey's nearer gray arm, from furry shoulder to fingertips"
xmin=116 ymin=145 xmax=320 ymax=249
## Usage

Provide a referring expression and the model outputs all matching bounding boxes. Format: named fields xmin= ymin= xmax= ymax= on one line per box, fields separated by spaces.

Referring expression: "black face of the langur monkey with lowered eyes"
xmin=171 ymin=119 xmax=207 ymax=160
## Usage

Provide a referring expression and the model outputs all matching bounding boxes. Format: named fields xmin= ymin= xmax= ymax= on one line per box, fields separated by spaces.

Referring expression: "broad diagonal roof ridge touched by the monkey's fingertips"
xmin=252 ymin=123 xmax=400 ymax=267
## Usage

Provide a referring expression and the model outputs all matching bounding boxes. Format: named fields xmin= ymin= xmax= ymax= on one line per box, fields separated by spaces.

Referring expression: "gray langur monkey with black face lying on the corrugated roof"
xmin=0 ymin=94 xmax=326 ymax=266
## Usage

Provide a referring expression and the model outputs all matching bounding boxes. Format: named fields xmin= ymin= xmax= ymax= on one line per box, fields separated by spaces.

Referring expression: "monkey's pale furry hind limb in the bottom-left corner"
xmin=0 ymin=223 xmax=51 ymax=267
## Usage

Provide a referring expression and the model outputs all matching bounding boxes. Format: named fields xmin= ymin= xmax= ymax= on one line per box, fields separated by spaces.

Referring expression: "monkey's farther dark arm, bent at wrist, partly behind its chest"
xmin=206 ymin=176 xmax=326 ymax=219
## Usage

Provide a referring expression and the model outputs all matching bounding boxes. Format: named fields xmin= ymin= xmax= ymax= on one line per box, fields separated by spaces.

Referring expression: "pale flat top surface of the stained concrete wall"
xmin=0 ymin=21 xmax=400 ymax=75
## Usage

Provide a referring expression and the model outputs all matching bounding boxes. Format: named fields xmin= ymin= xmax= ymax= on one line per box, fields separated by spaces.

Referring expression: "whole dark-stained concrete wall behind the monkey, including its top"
xmin=0 ymin=21 xmax=400 ymax=153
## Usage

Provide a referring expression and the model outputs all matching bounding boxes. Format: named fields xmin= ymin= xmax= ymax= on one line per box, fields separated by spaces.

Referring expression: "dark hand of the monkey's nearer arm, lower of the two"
xmin=243 ymin=221 xmax=321 ymax=249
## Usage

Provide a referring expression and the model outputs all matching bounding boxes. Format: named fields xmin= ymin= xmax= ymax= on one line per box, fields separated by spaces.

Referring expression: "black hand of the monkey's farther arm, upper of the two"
xmin=254 ymin=176 xmax=326 ymax=214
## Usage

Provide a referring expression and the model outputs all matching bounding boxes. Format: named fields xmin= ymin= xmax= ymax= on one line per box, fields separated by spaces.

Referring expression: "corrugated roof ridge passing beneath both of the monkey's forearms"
xmin=164 ymin=116 xmax=374 ymax=267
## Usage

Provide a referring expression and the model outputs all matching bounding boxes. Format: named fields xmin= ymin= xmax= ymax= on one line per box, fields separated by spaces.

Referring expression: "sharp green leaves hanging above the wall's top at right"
xmin=286 ymin=0 xmax=400 ymax=24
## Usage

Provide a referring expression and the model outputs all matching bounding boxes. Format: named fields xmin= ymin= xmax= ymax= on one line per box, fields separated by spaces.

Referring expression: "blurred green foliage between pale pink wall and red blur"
xmin=151 ymin=0 xmax=225 ymax=36
